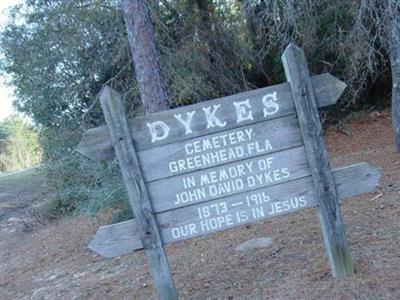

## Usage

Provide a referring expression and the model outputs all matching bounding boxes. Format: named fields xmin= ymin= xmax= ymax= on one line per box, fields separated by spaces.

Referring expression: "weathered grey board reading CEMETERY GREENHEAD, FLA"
xmin=138 ymin=115 xmax=303 ymax=181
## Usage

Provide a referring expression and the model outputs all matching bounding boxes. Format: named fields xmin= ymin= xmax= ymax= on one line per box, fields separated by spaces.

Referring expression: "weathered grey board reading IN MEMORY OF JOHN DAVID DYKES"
xmin=147 ymin=146 xmax=310 ymax=213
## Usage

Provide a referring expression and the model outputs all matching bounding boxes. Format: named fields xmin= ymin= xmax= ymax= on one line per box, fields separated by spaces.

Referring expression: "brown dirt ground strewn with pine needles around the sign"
xmin=0 ymin=111 xmax=400 ymax=299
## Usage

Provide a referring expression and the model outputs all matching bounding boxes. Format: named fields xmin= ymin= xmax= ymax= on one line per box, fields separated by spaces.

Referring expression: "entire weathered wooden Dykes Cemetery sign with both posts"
xmin=77 ymin=44 xmax=380 ymax=299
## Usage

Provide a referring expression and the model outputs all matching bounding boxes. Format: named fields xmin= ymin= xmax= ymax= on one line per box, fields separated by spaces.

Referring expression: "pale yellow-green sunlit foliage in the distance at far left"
xmin=0 ymin=116 xmax=41 ymax=172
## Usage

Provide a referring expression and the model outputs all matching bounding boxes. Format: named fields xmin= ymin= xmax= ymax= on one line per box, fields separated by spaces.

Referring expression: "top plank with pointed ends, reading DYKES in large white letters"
xmin=76 ymin=74 xmax=346 ymax=160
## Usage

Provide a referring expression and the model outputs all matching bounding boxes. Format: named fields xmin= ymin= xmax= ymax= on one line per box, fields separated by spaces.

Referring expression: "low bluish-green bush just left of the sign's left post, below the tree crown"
xmin=38 ymin=130 xmax=127 ymax=217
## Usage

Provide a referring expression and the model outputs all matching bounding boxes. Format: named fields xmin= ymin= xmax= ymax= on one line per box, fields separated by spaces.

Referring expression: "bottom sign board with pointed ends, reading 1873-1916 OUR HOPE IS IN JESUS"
xmin=89 ymin=163 xmax=380 ymax=258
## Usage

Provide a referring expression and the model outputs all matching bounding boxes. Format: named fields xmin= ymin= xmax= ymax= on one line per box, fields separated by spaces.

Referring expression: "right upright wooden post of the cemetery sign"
xmin=282 ymin=44 xmax=354 ymax=277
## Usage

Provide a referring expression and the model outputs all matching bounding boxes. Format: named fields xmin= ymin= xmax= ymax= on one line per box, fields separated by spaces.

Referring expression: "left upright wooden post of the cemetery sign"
xmin=100 ymin=86 xmax=178 ymax=300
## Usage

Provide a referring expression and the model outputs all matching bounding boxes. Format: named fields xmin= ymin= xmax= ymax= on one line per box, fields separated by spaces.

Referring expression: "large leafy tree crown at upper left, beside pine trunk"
xmin=1 ymin=1 xmax=130 ymax=128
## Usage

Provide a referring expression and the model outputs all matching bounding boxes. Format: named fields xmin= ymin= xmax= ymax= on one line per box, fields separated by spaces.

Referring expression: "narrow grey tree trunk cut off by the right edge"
xmin=388 ymin=0 xmax=400 ymax=152
